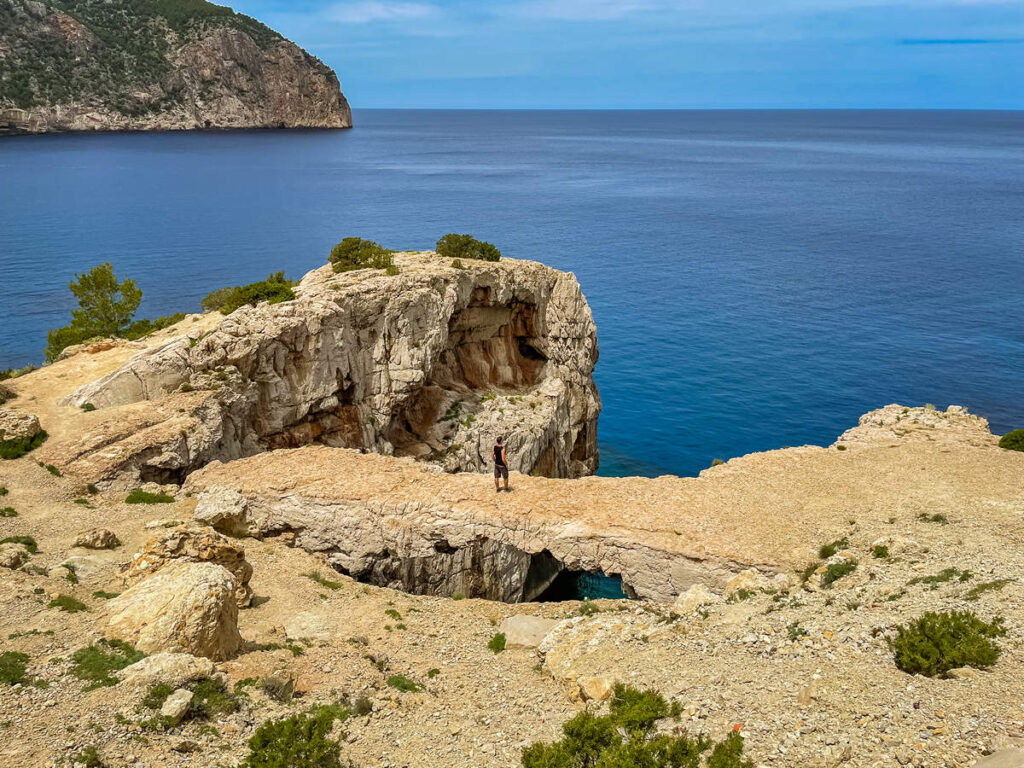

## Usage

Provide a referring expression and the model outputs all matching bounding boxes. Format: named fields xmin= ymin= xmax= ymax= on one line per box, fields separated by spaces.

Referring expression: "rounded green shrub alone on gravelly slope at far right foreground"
xmin=889 ymin=610 xmax=1007 ymax=677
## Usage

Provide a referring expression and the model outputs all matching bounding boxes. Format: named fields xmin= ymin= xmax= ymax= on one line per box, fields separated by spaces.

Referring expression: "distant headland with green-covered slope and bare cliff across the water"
xmin=0 ymin=0 xmax=352 ymax=133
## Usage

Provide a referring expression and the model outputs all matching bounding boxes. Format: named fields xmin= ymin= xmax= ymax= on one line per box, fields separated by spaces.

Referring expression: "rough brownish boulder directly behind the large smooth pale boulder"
xmin=126 ymin=523 xmax=253 ymax=607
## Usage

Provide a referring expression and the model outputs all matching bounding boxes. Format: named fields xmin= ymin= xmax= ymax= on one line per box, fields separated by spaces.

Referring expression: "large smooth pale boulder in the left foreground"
xmin=106 ymin=561 xmax=242 ymax=659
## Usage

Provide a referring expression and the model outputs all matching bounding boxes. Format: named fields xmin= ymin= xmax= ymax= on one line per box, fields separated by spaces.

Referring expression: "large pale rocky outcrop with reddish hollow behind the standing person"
xmin=62 ymin=259 xmax=600 ymax=485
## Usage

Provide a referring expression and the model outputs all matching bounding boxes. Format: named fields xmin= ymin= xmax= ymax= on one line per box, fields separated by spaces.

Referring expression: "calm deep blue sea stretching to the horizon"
xmin=0 ymin=111 xmax=1024 ymax=475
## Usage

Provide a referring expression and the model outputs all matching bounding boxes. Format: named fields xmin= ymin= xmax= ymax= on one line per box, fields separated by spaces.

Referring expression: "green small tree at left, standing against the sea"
xmin=46 ymin=263 xmax=142 ymax=362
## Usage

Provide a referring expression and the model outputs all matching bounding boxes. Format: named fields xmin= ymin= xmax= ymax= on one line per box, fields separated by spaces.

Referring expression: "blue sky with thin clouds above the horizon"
xmin=228 ymin=0 xmax=1024 ymax=110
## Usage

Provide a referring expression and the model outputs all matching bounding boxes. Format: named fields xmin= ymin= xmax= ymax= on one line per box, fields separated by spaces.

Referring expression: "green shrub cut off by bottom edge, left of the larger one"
xmin=243 ymin=707 xmax=349 ymax=768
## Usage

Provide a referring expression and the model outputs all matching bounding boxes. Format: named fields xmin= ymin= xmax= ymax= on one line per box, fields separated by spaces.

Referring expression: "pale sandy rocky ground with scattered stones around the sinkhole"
xmin=0 ymin=294 xmax=1024 ymax=768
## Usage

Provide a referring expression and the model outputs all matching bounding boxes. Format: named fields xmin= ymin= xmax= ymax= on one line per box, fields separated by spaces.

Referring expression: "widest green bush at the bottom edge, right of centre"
xmin=522 ymin=685 xmax=753 ymax=768
